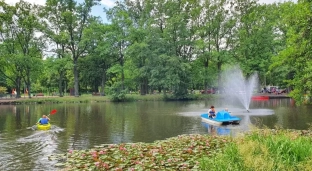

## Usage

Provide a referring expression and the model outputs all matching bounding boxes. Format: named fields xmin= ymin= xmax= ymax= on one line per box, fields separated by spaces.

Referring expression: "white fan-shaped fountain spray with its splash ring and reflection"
xmin=199 ymin=67 xmax=274 ymax=135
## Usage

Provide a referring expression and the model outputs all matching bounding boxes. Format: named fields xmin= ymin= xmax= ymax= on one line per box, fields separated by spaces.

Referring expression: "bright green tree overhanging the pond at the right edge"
xmin=271 ymin=0 xmax=312 ymax=104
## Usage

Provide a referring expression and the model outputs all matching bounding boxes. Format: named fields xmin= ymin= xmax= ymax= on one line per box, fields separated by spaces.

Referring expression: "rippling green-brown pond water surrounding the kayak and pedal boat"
xmin=0 ymin=99 xmax=312 ymax=170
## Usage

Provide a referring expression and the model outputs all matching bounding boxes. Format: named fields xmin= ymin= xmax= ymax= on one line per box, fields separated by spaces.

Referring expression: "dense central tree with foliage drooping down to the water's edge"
xmin=146 ymin=0 xmax=194 ymax=98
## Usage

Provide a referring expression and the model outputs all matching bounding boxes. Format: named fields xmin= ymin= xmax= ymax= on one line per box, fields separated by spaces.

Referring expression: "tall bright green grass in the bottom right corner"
xmin=201 ymin=129 xmax=312 ymax=171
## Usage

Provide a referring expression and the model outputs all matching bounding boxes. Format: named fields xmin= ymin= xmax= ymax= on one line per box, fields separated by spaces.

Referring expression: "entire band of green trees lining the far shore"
xmin=0 ymin=0 xmax=312 ymax=104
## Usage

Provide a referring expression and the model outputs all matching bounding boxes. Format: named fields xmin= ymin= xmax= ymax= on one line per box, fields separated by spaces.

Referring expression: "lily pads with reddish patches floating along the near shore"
xmin=50 ymin=134 xmax=232 ymax=171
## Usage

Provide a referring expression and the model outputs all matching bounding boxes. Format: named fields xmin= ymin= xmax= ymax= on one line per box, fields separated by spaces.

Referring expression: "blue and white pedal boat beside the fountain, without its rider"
xmin=201 ymin=110 xmax=241 ymax=125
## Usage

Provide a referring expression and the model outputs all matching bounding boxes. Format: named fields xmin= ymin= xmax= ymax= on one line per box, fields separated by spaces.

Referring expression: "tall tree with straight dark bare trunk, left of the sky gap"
xmin=43 ymin=0 xmax=99 ymax=97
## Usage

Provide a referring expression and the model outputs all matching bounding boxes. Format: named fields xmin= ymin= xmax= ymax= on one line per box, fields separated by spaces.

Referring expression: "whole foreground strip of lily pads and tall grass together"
xmin=50 ymin=129 xmax=312 ymax=171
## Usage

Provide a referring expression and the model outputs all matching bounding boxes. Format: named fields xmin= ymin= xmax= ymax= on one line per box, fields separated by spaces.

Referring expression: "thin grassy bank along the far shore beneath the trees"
xmin=0 ymin=94 xmax=218 ymax=104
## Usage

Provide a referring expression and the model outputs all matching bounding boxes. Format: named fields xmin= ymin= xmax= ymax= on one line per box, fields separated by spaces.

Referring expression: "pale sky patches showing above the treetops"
xmin=4 ymin=0 xmax=297 ymax=22
